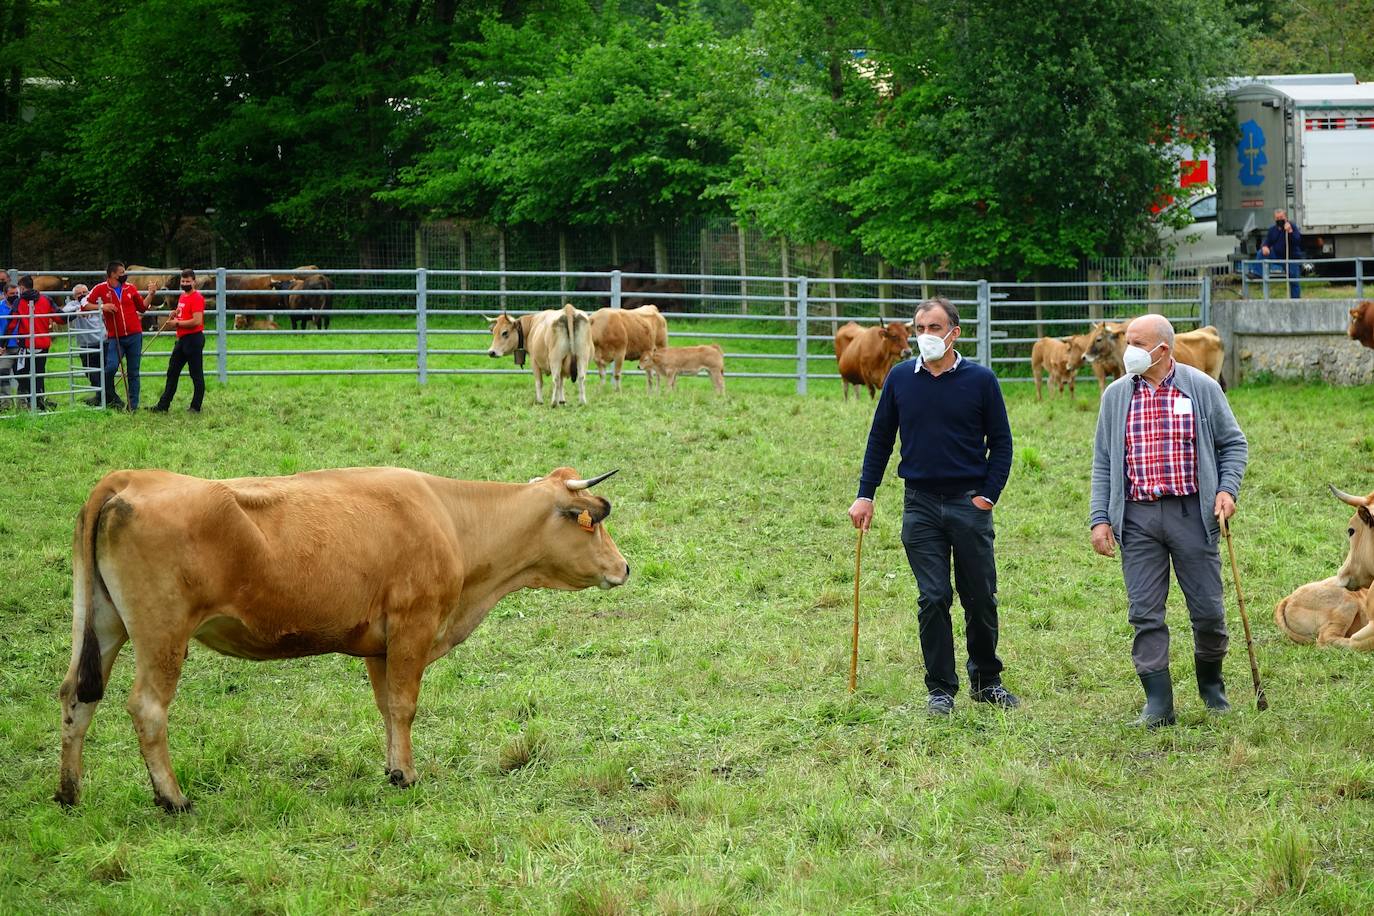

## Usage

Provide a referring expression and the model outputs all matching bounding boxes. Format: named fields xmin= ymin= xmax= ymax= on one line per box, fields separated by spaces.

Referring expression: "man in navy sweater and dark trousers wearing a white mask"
xmin=849 ymin=299 xmax=1018 ymax=715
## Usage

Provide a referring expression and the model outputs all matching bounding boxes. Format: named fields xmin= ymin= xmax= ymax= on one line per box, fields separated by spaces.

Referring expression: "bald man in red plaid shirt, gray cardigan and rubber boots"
xmin=1090 ymin=314 xmax=1249 ymax=728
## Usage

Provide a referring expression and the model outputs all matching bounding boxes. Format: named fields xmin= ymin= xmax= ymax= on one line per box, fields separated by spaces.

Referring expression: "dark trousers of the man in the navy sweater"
xmin=901 ymin=488 xmax=1002 ymax=696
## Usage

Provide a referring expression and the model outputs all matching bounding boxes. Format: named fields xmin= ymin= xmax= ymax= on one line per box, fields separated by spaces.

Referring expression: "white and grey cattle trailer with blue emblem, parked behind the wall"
xmin=1216 ymin=74 xmax=1374 ymax=260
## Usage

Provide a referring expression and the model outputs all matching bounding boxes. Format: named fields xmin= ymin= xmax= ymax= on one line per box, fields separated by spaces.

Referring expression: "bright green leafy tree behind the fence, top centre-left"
xmin=383 ymin=10 xmax=752 ymax=225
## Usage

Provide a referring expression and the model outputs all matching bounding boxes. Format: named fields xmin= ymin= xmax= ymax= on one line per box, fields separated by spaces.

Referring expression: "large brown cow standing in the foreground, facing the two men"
xmin=56 ymin=467 xmax=629 ymax=812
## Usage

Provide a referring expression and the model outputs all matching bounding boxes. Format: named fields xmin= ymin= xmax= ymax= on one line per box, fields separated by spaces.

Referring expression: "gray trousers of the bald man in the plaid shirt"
xmin=1121 ymin=496 xmax=1230 ymax=674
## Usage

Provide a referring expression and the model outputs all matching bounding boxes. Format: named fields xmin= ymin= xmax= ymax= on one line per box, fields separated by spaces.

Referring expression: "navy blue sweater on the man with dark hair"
xmin=859 ymin=360 xmax=1011 ymax=503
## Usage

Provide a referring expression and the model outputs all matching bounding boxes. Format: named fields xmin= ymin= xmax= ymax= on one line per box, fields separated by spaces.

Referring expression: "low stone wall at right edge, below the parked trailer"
xmin=1212 ymin=299 xmax=1374 ymax=385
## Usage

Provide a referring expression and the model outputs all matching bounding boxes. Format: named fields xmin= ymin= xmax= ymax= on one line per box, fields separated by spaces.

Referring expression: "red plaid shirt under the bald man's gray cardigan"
xmin=1125 ymin=368 xmax=1198 ymax=501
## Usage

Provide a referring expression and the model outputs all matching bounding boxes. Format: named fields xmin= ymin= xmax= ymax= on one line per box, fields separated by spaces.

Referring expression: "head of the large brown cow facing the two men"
xmin=529 ymin=467 xmax=629 ymax=589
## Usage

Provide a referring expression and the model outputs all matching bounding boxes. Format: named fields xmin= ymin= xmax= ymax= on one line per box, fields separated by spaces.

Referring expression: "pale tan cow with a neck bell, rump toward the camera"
xmin=486 ymin=302 xmax=592 ymax=407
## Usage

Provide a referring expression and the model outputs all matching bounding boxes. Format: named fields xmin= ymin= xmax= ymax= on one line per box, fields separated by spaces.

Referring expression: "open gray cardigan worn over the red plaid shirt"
xmin=1090 ymin=363 xmax=1250 ymax=544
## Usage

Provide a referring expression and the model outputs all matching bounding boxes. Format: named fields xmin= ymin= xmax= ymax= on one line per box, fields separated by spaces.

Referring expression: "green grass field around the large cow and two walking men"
xmin=0 ymin=378 xmax=1374 ymax=913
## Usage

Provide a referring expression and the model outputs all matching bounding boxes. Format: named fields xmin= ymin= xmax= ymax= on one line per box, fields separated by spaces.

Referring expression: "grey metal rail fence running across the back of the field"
xmin=10 ymin=268 xmax=1212 ymax=403
